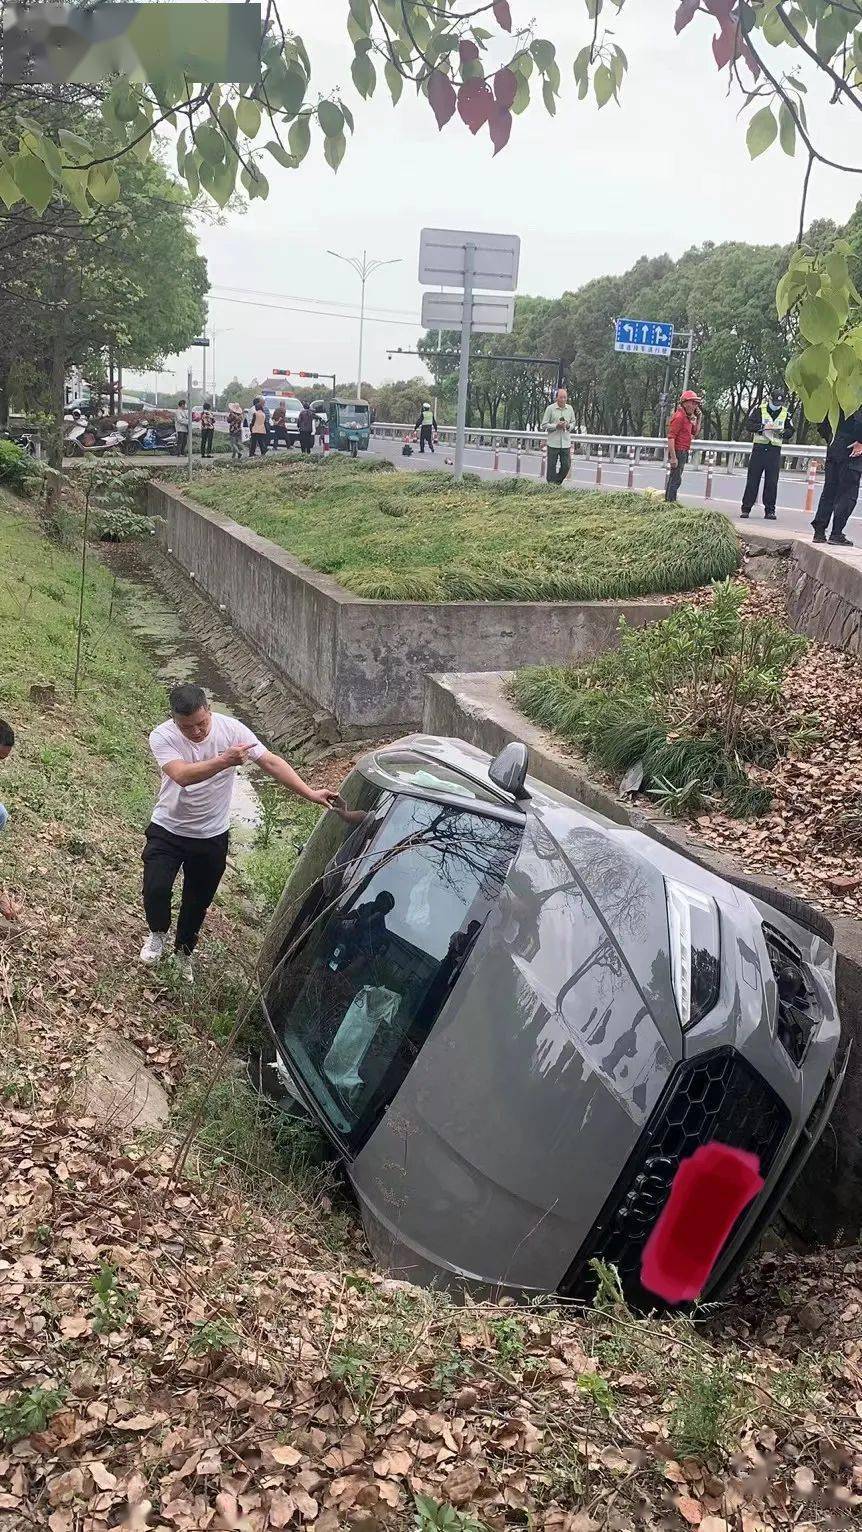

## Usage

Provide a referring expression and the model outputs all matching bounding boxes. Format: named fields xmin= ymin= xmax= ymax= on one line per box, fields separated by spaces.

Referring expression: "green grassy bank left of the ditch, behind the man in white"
xmin=0 ymin=489 xmax=165 ymax=833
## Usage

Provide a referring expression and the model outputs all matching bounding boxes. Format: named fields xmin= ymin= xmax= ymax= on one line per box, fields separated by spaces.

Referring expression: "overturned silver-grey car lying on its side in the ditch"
xmin=262 ymin=735 xmax=845 ymax=1304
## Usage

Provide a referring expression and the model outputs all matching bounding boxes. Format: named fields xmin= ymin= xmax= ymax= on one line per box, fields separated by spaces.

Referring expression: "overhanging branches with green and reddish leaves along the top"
xmin=0 ymin=0 xmax=862 ymax=420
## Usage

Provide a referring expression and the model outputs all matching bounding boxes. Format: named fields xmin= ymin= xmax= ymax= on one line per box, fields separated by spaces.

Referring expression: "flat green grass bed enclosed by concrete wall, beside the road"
xmin=182 ymin=458 xmax=740 ymax=601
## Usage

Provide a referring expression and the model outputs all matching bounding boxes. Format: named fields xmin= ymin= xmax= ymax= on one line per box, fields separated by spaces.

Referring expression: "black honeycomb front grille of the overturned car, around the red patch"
xmin=559 ymin=1048 xmax=790 ymax=1307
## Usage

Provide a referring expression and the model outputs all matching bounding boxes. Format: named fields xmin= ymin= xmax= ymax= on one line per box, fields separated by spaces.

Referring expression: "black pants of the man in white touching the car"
xmin=141 ymin=824 xmax=228 ymax=953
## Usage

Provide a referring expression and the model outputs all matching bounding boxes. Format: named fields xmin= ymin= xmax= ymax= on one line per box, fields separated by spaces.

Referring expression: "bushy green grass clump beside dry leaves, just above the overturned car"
xmin=511 ymin=581 xmax=811 ymax=818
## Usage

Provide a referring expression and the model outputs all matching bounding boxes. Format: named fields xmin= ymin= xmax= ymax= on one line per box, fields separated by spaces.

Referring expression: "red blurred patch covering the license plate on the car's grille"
xmin=640 ymin=1141 xmax=764 ymax=1304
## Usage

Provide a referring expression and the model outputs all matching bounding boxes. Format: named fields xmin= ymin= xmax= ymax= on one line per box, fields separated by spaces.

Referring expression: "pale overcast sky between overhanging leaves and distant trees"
xmin=124 ymin=0 xmax=862 ymax=388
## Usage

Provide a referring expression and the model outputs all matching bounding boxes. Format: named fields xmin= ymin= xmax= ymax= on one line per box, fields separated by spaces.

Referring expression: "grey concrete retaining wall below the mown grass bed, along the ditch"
xmin=149 ymin=483 xmax=668 ymax=735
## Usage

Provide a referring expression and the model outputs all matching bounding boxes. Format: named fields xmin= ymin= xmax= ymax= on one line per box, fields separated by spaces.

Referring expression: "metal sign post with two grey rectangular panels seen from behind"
xmin=420 ymin=228 xmax=521 ymax=483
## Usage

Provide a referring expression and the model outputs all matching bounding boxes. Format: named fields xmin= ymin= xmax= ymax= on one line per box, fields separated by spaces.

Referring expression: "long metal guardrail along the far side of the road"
xmin=372 ymin=420 xmax=827 ymax=469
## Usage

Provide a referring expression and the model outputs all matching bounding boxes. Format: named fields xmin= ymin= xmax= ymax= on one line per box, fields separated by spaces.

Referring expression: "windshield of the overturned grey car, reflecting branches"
xmin=265 ymin=778 xmax=521 ymax=1151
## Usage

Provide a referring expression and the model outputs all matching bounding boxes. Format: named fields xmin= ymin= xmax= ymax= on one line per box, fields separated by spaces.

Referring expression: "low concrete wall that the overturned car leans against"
xmin=423 ymin=673 xmax=862 ymax=1242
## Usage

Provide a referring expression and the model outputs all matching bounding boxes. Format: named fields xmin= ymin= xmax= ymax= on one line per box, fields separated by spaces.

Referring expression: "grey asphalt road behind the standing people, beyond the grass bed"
xmin=371 ymin=437 xmax=839 ymax=547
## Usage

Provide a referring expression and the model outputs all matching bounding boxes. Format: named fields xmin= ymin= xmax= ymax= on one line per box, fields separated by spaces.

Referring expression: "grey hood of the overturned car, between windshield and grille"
xmin=351 ymin=807 xmax=681 ymax=1290
